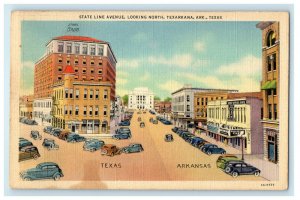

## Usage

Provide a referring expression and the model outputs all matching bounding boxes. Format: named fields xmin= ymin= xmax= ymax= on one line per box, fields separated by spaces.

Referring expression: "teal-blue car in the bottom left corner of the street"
xmin=20 ymin=162 xmax=64 ymax=181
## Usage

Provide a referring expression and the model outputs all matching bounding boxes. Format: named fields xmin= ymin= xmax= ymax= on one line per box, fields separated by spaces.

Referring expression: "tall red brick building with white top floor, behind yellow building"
xmin=34 ymin=36 xmax=117 ymax=101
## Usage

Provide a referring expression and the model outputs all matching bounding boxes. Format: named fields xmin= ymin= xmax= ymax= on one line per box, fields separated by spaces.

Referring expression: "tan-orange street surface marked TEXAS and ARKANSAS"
xmin=20 ymin=112 xmax=265 ymax=181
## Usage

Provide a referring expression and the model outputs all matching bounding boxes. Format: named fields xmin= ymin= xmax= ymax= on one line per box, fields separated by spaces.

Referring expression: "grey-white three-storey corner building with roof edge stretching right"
xmin=172 ymin=85 xmax=237 ymax=128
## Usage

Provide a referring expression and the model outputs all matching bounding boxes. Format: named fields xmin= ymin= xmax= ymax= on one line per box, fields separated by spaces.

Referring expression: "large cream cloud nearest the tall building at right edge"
xmin=217 ymin=55 xmax=262 ymax=77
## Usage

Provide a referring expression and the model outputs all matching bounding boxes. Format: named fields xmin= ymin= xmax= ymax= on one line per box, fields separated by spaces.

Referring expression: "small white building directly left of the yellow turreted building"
xmin=33 ymin=97 xmax=52 ymax=126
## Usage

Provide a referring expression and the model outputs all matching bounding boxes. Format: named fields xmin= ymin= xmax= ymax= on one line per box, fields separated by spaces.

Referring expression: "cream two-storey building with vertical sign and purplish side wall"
xmin=207 ymin=92 xmax=263 ymax=154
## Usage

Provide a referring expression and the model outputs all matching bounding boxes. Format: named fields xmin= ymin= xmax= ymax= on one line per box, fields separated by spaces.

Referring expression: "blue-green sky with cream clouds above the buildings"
xmin=21 ymin=21 xmax=262 ymax=98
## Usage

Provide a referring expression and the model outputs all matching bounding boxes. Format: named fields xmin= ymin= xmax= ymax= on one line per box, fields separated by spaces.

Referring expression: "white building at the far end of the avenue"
xmin=128 ymin=87 xmax=154 ymax=110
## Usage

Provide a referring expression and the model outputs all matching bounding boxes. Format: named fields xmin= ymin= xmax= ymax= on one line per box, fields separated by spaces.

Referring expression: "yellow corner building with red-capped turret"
xmin=52 ymin=66 xmax=111 ymax=134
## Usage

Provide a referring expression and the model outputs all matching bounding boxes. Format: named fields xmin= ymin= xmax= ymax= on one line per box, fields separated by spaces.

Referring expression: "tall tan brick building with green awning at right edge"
xmin=256 ymin=22 xmax=280 ymax=163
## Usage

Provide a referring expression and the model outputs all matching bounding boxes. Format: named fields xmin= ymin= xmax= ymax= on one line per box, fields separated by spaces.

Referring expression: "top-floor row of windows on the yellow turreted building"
xmin=54 ymin=88 xmax=108 ymax=100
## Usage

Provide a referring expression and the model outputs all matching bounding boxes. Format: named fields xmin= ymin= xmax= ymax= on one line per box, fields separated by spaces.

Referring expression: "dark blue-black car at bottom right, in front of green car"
xmin=225 ymin=162 xmax=260 ymax=177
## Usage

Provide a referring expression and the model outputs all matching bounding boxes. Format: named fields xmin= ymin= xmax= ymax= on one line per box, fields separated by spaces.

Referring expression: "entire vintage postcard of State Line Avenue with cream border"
xmin=10 ymin=11 xmax=289 ymax=190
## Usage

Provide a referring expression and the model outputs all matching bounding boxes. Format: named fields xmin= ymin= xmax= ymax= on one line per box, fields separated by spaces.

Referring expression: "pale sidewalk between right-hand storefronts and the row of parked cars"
xmin=195 ymin=129 xmax=279 ymax=181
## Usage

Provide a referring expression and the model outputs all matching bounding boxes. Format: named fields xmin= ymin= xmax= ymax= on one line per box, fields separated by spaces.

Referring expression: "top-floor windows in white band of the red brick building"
xmin=57 ymin=42 xmax=104 ymax=56
